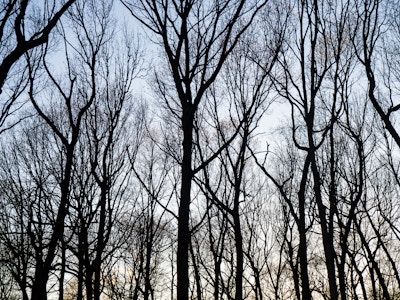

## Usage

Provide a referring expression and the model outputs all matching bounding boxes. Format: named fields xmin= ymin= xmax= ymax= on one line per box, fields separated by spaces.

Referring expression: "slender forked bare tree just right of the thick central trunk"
xmin=191 ymin=15 xmax=284 ymax=299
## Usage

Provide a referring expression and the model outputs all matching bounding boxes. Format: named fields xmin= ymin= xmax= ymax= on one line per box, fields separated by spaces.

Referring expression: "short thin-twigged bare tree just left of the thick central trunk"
xmin=121 ymin=129 xmax=176 ymax=300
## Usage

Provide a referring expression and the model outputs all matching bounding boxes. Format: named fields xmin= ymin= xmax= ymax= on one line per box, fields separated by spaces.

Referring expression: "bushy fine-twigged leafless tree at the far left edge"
xmin=1 ymin=118 xmax=62 ymax=299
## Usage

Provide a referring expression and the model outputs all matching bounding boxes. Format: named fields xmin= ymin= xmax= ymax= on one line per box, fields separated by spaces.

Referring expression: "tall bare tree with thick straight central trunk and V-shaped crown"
xmin=122 ymin=0 xmax=266 ymax=300
